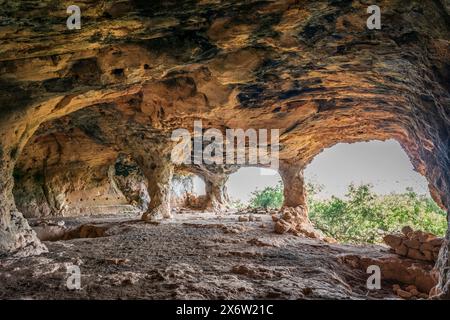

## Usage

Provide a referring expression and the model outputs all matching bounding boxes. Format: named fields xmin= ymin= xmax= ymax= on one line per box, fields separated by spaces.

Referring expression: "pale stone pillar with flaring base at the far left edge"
xmin=0 ymin=144 xmax=47 ymax=256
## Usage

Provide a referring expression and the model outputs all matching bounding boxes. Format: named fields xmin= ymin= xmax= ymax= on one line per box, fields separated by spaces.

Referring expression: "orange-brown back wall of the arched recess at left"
xmin=13 ymin=126 xmax=150 ymax=218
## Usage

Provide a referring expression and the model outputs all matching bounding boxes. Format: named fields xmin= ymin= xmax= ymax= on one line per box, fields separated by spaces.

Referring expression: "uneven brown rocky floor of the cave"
xmin=0 ymin=213 xmax=396 ymax=299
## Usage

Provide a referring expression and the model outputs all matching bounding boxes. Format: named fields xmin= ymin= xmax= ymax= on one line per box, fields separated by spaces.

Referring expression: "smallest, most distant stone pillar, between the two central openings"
xmin=205 ymin=175 xmax=230 ymax=212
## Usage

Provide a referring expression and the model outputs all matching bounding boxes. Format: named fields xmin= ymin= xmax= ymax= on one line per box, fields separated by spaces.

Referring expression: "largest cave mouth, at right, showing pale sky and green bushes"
xmin=304 ymin=140 xmax=447 ymax=244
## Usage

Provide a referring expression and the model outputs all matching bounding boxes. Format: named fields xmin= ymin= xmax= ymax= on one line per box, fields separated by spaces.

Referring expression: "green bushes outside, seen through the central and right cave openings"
xmin=250 ymin=183 xmax=447 ymax=243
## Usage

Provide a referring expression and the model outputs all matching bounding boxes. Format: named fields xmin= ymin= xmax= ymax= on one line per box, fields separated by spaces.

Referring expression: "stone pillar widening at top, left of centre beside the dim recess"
xmin=137 ymin=156 xmax=174 ymax=221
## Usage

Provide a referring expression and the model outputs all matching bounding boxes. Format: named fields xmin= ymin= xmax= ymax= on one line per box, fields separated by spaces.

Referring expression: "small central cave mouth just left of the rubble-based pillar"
xmin=226 ymin=167 xmax=283 ymax=209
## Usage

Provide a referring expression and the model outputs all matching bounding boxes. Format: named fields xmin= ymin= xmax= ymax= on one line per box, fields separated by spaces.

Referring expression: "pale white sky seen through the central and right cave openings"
xmin=227 ymin=140 xmax=429 ymax=202
